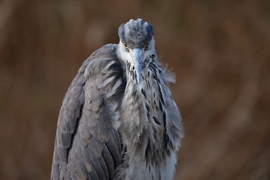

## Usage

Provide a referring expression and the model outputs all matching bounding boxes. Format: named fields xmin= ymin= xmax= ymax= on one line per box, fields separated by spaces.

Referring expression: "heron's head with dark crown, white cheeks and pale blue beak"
xmin=118 ymin=19 xmax=156 ymax=83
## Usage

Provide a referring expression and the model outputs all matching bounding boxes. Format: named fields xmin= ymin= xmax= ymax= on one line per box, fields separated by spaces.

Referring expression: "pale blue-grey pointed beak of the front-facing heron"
xmin=131 ymin=48 xmax=144 ymax=83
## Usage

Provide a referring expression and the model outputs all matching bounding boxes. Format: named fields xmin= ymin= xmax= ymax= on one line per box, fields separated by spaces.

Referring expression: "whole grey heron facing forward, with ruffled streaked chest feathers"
xmin=51 ymin=19 xmax=183 ymax=180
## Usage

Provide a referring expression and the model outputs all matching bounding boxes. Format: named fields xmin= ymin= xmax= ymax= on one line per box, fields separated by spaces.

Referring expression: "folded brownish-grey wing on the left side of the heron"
xmin=51 ymin=45 xmax=125 ymax=180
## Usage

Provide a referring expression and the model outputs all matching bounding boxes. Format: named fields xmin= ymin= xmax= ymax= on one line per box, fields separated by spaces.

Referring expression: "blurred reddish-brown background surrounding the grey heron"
xmin=0 ymin=0 xmax=270 ymax=180
